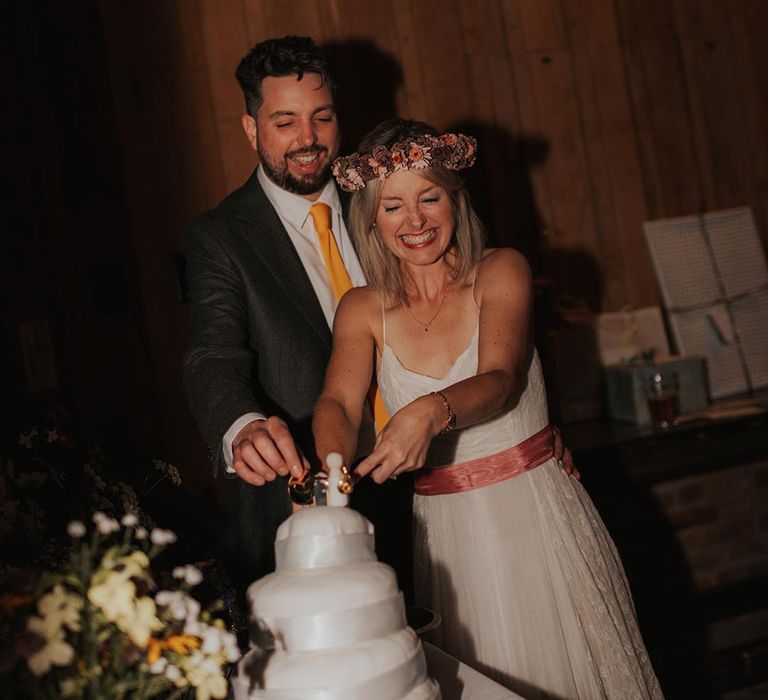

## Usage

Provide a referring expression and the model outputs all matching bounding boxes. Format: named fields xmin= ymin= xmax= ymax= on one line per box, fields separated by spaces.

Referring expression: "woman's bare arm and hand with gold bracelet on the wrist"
xmin=357 ymin=249 xmax=533 ymax=483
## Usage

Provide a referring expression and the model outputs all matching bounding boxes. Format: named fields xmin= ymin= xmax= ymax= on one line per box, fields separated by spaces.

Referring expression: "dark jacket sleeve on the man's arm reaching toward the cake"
xmin=182 ymin=213 xmax=264 ymax=474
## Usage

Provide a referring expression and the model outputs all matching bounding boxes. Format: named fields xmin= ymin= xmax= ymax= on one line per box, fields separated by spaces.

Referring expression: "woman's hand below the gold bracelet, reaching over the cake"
xmin=355 ymin=396 xmax=443 ymax=484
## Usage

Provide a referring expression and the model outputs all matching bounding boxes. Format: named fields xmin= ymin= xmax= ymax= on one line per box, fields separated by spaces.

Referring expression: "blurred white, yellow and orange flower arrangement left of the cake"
xmin=0 ymin=511 xmax=240 ymax=700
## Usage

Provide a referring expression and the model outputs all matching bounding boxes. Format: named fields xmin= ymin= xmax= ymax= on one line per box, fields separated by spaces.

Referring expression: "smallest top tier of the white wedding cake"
xmin=275 ymin=506 xmax=376 ymax=571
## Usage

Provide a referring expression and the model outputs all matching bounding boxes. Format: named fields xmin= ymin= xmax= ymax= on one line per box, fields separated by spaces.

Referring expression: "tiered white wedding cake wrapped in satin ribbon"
xmin=233 ymin=506 xmax=440 ymax=700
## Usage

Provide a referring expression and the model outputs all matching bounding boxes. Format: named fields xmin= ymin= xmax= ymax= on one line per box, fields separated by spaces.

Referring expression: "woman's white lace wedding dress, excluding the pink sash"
xmin=378 ymin=316 xmax=663 ymax=700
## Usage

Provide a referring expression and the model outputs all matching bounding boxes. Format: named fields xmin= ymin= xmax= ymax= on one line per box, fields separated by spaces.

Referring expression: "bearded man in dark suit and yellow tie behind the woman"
xmin=183 ymin=36 xmax=570 ymax=591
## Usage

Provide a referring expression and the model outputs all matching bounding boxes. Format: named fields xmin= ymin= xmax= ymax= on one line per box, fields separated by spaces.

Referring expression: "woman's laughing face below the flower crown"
xmin=376 ymin=170 xmax=456 ymax=265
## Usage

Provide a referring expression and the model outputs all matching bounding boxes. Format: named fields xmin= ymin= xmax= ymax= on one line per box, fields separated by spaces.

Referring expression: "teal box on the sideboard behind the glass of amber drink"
xmin=604 ymin=356 xmax=708 ymax=425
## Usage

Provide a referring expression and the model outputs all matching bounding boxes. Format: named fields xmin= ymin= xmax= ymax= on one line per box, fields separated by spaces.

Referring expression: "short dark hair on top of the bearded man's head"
xmin=235 ymin=35 xmax=336 ymax=118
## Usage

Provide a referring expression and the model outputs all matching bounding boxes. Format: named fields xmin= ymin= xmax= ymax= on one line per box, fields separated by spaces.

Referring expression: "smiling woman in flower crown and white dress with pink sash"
xmin=313 ymin=120 xmax=662 ymax=700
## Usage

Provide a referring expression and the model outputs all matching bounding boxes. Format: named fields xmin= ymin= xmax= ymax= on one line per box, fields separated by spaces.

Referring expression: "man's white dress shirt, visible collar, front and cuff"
xmin=222 ymin=166 xmax=366 ymax=473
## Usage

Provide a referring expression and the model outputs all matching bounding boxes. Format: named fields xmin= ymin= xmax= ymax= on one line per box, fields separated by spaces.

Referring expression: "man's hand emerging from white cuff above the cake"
xmin=232 ymin=416 xmax=309 ymax=486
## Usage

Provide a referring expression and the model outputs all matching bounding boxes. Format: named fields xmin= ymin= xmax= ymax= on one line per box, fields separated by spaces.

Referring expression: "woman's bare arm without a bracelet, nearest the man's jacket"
xmin=312 ymin=289 xmax=377 ymax=474
